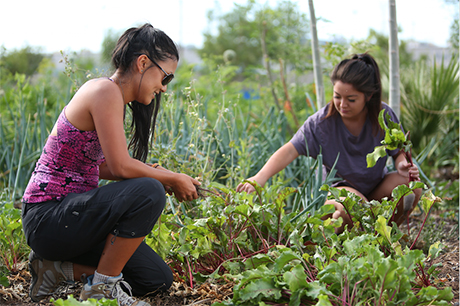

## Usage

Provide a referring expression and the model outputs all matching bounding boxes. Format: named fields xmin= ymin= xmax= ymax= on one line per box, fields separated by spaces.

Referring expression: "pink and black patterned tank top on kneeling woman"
xmin=22 ymin=107 xmax=104 ymax=203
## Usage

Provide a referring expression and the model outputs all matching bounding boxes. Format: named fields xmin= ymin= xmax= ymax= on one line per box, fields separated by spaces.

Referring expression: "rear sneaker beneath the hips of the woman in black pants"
xmin=29 ymin=251 xmax=67 ymax=302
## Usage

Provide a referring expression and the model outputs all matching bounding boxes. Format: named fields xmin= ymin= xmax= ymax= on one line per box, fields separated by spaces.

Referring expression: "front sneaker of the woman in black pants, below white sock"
xmin=80 ymin=273 xmax=150 ymax=306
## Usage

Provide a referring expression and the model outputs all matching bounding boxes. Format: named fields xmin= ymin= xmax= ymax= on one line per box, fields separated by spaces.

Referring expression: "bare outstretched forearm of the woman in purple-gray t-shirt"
xmin=236 ymin=142 xmax=299 ymax=193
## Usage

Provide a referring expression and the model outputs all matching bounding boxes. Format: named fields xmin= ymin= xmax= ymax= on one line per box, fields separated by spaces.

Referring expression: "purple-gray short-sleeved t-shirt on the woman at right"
xmin=291 ymin=102 xmax=399 ymax=195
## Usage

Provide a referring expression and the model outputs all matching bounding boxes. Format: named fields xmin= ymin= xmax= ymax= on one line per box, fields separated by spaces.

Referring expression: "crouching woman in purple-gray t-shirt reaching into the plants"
xmin=237 ymin=54 xmax=422 ymax=231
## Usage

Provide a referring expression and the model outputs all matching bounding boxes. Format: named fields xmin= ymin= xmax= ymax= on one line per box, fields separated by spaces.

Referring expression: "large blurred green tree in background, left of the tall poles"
xmin=198 ymin=0 xmax=309 ymax=69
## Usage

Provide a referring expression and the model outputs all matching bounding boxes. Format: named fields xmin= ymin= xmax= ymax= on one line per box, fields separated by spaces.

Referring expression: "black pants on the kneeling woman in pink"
xmin=22 ymin=178 xmax=173 ymax=295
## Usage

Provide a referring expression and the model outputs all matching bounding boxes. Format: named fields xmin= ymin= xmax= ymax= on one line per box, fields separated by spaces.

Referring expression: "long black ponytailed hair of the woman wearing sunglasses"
xmin=112 ymin=23 xmax=179 ymax=162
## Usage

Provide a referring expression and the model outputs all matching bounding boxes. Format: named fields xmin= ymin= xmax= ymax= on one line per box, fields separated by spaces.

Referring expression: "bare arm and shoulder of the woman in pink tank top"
xmin=66 ymin=82 xmax=200 ymax=201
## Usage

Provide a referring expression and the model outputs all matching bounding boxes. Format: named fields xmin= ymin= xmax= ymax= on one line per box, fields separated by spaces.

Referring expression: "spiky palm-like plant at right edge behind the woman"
xmin=401 ymin=54 xmax=459 ymax=154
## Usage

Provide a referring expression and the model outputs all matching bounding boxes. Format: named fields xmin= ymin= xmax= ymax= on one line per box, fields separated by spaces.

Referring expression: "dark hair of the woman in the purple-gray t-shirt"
xmin=326 ymin=53 xmax=382 ymax=135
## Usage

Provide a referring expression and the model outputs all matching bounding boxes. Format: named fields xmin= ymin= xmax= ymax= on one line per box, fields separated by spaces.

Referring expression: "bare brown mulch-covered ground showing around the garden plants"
xmin=0 ymin=213 xmax=459 ymax=306
